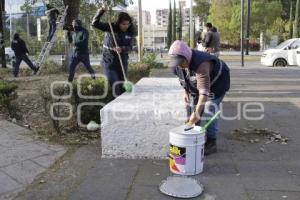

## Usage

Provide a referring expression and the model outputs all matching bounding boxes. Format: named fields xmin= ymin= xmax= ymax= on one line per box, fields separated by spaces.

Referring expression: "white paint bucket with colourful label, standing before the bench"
xmin=169 ymin=125 xmax=205 ymax=175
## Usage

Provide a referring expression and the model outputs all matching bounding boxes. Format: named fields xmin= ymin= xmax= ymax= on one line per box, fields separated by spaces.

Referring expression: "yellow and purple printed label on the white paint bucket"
xmin=169 ymin=144 xmax=186 ymax=172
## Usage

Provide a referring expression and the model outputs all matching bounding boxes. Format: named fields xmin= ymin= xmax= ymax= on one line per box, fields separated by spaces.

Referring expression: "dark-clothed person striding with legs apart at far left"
xmin=11 ymin=33 xmax=39 ymax=77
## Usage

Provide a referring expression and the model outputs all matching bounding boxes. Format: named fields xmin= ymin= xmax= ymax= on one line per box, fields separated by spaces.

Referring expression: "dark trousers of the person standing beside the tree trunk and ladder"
xmin=68 ymin=54 xmax=95 ymax=82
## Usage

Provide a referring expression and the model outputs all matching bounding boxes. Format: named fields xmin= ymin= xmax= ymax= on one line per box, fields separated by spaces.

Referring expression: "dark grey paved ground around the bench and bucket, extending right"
xmin=16 ymin=63 xmax=300 ymax=200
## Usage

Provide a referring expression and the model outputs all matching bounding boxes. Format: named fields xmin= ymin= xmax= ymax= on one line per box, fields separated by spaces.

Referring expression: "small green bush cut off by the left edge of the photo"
xmin=0 ymin=80 xmax=18 ymax=117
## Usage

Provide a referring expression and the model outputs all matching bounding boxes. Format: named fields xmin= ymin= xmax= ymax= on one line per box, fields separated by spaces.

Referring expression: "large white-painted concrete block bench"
xmin=100 ymin=78 xmax=186 ymax=159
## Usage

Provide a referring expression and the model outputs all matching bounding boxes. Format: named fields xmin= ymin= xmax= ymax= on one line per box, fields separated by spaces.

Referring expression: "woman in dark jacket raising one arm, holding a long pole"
xmin=92 ymin=7 xmax=135 ymax=96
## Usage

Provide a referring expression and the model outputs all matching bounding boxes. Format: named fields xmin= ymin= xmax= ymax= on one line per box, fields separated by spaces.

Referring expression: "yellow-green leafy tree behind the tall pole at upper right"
xmin=208 ymin=0 xmax=282 ymax=44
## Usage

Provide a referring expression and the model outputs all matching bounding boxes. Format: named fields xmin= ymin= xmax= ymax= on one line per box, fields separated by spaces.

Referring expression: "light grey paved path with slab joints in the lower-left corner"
xmin=0 ymin=121 xmax=66 ymax=200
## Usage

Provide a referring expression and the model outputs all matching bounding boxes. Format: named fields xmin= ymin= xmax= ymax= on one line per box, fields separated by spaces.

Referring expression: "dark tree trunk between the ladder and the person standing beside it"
xmin=64 ymin=0 xmax=80 ymax=70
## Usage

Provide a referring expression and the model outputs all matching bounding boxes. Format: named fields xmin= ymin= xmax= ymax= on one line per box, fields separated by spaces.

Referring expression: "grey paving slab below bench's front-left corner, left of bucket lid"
xmin=70 ymin=159 xmax=141 ymax=200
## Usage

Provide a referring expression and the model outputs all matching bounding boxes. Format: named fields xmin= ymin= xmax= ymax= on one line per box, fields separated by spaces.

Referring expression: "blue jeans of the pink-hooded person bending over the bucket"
xmin=186 ymin=94 xmax=225 ymax=139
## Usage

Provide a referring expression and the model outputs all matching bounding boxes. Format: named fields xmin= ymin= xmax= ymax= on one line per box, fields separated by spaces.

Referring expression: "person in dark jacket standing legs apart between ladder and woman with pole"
xmin=68 ymin=19 xmax=95 ymax=82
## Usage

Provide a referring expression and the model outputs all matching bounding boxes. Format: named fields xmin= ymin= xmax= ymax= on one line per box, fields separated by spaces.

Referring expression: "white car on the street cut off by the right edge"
xmin=260 ymin=38 xmax=300 ymax=67
